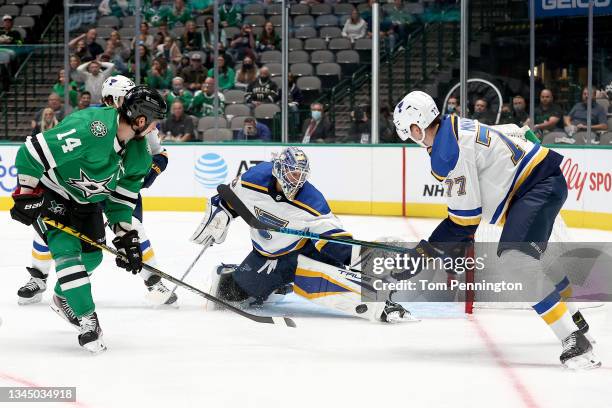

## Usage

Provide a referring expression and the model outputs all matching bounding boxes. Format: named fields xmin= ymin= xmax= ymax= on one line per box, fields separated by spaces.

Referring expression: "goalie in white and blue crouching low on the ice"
xmin=191 ymin=147 xmax=412 ymax=322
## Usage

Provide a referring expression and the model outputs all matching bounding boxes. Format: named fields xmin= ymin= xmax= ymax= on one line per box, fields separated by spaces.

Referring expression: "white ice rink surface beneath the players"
xmin=0 ymin=212 xmax=612 ymax=408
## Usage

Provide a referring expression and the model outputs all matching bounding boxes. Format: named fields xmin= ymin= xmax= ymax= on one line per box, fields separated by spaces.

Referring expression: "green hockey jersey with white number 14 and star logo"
xmin=15 ymin=107 xmax=152 ymax=224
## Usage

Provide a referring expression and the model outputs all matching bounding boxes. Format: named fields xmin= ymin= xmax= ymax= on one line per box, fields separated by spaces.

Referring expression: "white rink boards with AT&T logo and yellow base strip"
xmin=0 ymin=144 xmax=612 ymax=230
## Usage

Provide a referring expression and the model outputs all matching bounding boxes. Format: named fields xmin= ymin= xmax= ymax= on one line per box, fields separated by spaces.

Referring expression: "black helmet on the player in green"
xmin=119 ymin=85 xmax=168 ymax=127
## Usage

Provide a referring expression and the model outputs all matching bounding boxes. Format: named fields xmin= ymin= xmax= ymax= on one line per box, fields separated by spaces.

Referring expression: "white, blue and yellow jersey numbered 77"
xmin=429 ymin=115 xmax=561 ymax=226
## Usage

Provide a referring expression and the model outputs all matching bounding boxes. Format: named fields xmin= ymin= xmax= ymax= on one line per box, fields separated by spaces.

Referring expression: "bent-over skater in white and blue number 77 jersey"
xmin=393 ymin=91 xmax=601 ymax=368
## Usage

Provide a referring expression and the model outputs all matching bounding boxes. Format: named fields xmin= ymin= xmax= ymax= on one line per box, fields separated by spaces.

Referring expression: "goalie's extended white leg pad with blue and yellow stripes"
xmin=293 ymin=255 xmax=385 ymax=320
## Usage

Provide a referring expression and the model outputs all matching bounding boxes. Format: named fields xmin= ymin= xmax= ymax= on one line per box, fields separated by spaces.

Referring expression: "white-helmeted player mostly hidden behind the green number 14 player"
xmin=17 ymin=75 xmax=177 ymax=311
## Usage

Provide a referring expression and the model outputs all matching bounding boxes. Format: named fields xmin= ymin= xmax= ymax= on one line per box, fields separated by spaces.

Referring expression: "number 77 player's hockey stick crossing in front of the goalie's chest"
xmin=217 ymin=184 xmax=410 ymax=253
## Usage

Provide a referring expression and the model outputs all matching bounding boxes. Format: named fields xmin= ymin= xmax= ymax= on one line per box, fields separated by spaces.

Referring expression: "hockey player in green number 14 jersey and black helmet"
xmin=11 ymin=86 xmax=167 ymax=353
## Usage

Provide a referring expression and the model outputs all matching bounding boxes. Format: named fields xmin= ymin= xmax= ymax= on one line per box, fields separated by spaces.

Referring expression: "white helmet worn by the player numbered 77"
xmin=393 ymin=91 xmax=440 ymax=147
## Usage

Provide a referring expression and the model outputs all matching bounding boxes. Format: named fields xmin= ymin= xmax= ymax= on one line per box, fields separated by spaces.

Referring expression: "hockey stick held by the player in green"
xmin=41 ymin=217 xmax=296 ymax=327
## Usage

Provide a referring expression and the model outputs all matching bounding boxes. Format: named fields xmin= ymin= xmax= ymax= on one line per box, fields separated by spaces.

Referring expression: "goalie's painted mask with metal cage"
xmin=272 ymin=146 xmax=310 ymax=201
